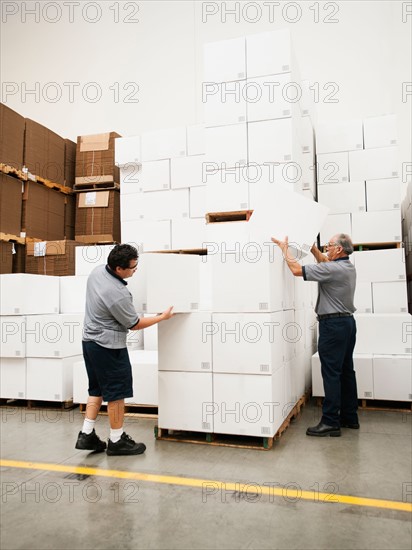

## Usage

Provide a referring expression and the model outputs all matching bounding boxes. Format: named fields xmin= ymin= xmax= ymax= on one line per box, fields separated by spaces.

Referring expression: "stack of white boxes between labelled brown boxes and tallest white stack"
xmin=116 ymin=126 xmax=205 ymax=252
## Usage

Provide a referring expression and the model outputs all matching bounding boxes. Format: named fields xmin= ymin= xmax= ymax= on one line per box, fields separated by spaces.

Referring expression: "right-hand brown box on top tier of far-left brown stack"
xmin=24 ymin=118 xmax=65 ymax=185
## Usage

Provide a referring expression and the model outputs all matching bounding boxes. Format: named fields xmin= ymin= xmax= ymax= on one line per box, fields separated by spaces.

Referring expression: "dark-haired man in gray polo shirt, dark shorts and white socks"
xmin=76 ymin=244 xmax=173 ymax=455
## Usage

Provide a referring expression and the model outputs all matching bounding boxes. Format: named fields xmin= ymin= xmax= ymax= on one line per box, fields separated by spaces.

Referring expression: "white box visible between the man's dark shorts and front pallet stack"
xmin=125 ymin=350 xmax=159 ymax=405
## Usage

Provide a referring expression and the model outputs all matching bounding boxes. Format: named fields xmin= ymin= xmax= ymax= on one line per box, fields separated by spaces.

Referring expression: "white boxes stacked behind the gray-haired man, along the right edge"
xmin=312 ymin=115 xmax=412 ymax=401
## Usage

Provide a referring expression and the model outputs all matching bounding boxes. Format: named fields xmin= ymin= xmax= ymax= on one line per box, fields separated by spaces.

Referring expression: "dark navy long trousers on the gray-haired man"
xmin=318 ymin=317 xmax=358 ymax=426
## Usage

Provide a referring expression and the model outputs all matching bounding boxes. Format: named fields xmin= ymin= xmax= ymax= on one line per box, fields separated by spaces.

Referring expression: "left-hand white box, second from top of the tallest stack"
xmin=203 ymin=80 xmax=246 ymax=127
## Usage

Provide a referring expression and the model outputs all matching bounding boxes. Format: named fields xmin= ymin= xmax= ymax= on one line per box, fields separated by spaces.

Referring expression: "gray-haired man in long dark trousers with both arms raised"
xmin=272 ymin=233 xmax=359 ymax=436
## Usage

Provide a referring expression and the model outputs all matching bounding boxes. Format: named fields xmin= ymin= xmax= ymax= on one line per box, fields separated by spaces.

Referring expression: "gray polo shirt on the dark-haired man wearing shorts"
xmin=83 ymin=265 xmax=139 ymax=349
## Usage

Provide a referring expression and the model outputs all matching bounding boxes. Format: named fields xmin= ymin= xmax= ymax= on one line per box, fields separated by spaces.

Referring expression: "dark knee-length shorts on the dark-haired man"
xmin=82 ymin=341 xmax=133 ymax=401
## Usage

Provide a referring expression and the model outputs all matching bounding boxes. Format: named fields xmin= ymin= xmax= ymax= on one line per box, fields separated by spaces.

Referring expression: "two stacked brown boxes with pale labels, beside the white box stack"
xmin=75 ymin=132 xmax=121 ymax=243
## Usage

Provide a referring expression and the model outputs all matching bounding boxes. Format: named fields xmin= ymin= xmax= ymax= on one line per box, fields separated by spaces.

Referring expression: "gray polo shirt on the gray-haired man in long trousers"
xmin=302 ymin=256 xmax=356 ymax=315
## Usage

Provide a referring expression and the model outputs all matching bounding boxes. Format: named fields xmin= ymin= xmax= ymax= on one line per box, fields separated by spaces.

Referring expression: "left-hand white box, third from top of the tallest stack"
xmin=204 ymin=123 xmax=248 ymax=171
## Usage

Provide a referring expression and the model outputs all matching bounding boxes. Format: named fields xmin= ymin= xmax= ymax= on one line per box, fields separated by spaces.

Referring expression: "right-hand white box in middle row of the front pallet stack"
xmin=212 ymin=311 xmax=288 ymax=375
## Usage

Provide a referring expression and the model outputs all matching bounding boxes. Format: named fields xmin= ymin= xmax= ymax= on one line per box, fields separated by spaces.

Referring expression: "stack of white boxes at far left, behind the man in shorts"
xmin=0 ymin=274 xmax=82 ymax=402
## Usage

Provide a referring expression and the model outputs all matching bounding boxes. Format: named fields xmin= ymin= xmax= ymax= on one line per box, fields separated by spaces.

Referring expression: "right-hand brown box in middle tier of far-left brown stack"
xmin=22 ymin=181 xmax=67 ymax=241
